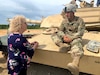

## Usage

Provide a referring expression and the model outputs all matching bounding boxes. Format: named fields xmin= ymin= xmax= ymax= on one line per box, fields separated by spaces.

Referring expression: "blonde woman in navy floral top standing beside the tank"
xmin=7 ymin=15 xmax=38 ymax=75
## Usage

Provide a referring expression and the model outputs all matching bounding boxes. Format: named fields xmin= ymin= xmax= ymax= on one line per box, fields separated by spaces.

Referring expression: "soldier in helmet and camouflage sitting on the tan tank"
xmin=51 ymin=4 xmax=85 ymax=75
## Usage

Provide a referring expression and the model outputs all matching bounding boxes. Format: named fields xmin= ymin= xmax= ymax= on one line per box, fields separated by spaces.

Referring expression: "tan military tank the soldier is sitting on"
xmin=0 ymin=7 xmax=100 ymax=75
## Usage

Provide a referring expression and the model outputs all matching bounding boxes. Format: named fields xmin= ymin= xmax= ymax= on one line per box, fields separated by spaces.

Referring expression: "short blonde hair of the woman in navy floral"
xmin=8 ymin=15 xmax=26 ymax=33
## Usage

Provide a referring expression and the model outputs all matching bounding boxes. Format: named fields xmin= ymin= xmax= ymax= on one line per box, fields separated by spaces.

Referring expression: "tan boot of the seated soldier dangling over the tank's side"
xmin=67 ymin=56 xmax=80 ymax=75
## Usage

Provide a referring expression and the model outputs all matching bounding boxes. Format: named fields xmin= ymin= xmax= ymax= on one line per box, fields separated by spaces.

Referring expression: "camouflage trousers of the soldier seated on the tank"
xmin=51 ymin=31 xmax=84 ymax=57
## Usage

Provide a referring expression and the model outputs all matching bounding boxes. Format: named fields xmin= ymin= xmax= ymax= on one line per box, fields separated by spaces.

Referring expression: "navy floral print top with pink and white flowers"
xmin=7 ymin=33 xmax=34 ymax=75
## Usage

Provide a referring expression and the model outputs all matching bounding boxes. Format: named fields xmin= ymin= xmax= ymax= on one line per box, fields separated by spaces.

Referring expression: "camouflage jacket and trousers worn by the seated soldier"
xmin=51 ymin=17 xmax=85 ymax=55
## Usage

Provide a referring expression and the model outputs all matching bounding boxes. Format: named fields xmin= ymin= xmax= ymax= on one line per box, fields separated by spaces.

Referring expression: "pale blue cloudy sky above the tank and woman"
xmin=0 ymin=0 xmax=96 ymax=24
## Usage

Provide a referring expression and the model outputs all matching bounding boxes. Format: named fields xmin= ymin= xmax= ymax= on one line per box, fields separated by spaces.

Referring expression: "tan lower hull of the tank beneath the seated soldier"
xmin=29 ymin=33 xmax=100 ymax=75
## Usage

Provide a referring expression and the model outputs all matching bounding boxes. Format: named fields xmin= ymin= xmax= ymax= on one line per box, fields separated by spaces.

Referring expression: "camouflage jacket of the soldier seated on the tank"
xmin=59 ymin=16 xmax=85 ymax=40
